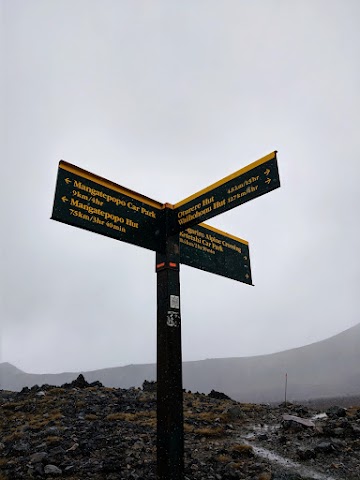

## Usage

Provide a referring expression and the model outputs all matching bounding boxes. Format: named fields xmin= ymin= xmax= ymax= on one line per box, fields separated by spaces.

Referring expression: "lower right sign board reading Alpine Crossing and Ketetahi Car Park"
xmin=180 ymin=223 xmax=252 ymax=285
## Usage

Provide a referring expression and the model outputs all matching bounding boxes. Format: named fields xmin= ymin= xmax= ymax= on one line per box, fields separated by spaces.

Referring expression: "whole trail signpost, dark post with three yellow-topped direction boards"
xmin=51 ymin=152 xmax=280 ymax=480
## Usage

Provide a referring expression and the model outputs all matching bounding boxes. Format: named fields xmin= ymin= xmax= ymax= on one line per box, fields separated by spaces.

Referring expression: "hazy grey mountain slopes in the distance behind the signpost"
xmin=0 ymin=324 xmax=360 ymax=402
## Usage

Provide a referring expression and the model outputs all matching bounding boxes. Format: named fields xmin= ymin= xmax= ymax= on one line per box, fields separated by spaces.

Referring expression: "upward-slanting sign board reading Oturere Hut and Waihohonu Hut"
xmin=174 ymin=152 xmax=280 ymax=233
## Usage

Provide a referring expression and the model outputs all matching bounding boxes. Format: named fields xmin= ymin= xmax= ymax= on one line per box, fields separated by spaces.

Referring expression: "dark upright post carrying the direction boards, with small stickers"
xmin=156 ymin=223 xmax=184 ymax=480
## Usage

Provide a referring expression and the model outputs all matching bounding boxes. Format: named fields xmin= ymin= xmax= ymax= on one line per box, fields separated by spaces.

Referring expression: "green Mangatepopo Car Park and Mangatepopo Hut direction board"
xmin=51 ymin=161 xmax=165 ymax=251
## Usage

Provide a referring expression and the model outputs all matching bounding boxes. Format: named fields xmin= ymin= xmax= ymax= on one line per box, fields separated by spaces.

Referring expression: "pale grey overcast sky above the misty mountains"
xmin=0 ymin=0 xmax=360 ymax=373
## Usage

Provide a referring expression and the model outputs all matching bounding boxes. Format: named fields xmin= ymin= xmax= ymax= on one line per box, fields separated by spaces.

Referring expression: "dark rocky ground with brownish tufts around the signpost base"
xmin=0 ymin=377 xmax=360 ymax=480
